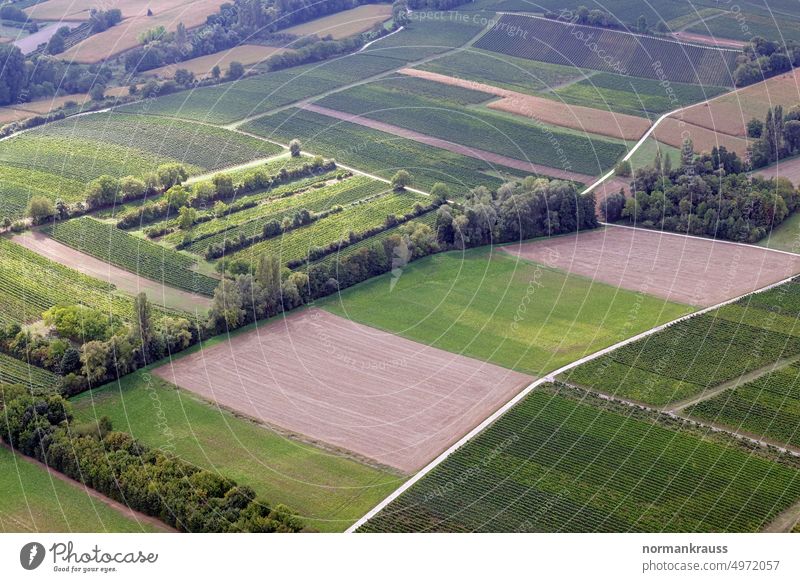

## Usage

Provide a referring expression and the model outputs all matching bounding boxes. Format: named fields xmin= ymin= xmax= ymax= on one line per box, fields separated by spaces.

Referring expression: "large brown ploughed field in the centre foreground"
xmin=155 ymin=309 xmax=532 ymax=472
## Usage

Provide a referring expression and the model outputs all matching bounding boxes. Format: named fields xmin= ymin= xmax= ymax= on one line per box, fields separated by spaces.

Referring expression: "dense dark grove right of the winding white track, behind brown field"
xmin=605 ymin=147 xmax=800 ymax=243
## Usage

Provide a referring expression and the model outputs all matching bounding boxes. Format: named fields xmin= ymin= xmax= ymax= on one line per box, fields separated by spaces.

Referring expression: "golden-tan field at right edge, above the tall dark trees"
xmin=681 ymin=69 xmax=800 ymax=138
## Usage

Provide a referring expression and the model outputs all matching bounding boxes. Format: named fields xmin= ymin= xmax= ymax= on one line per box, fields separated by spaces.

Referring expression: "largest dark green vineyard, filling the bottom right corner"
xmin=359 ymin=384 xmax=800 ymax=532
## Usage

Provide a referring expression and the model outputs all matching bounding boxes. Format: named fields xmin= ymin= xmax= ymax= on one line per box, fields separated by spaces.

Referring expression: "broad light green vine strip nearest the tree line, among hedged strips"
xmin=228 ymin=192 xmax=430 ymax=264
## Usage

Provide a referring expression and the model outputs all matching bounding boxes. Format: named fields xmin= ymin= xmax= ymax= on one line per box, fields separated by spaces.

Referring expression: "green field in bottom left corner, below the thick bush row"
xmin=0 ymin=447 xmax=158 ymax=533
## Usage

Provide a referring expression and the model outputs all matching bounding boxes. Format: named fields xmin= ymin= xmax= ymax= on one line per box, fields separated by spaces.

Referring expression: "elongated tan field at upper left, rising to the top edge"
xmin=60 ymin=0 xmax=228 ymax=63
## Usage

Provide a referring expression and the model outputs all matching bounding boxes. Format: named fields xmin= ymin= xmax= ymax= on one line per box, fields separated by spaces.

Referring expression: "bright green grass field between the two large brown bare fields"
xmin=322 ymin=249 xmax=691 ymax=376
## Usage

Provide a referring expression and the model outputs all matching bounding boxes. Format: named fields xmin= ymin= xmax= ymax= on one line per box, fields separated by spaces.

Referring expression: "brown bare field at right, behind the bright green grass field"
xmin=503 ymin=226 xmax=800 ymax=306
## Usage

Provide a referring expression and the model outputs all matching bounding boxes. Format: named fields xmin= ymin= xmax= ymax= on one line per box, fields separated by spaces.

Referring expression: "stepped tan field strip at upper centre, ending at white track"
xmin=400 ymin=69 xmax=650 ymax=141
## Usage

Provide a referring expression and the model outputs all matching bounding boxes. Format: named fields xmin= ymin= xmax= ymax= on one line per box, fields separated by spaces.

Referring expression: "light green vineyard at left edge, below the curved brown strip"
xmin=0 ymin=238 xmax=142 ymax=325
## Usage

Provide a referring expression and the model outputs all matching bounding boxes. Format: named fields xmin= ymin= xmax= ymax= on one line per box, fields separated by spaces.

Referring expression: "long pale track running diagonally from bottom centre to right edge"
xmin=345 ymin=270 xmax=794 ymax=533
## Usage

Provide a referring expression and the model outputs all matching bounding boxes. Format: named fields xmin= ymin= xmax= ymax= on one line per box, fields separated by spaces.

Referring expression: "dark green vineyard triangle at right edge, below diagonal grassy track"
xmin=683 ymin=362 xmax=800 ymax=448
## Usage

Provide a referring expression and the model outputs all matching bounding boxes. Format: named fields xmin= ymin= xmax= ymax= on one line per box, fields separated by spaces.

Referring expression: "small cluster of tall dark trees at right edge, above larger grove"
xmin=747 ymin=105 xmax=800 ymax=168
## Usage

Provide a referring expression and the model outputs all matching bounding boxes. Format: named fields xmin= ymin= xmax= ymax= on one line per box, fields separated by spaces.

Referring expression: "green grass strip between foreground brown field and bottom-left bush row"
xmin=73 ymin=371 xmax=403 ymax=531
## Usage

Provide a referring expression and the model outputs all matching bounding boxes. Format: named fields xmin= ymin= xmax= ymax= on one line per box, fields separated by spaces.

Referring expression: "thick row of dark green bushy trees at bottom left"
xmin=0 ymin=384 xmax=303 ymax=533
